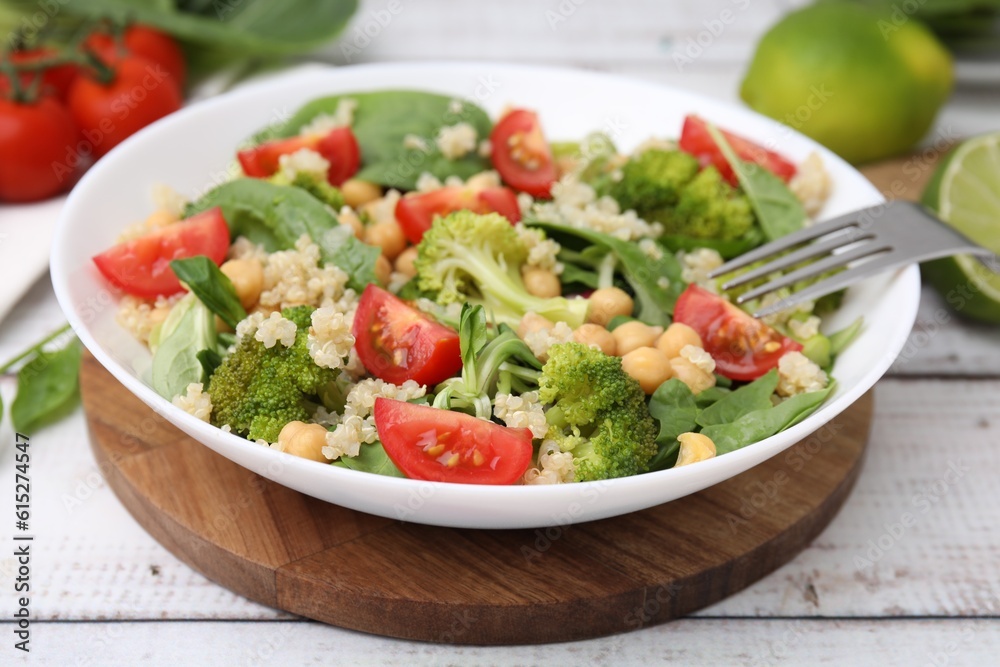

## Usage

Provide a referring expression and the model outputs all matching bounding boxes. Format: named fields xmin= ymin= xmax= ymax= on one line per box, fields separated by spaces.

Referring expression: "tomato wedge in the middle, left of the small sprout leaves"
xmin=351 ymin=285 xmax=462 ymax=385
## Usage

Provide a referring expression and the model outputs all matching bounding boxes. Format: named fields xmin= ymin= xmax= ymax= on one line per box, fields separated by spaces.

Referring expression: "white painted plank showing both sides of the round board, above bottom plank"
xmin=0 ymin=379 xmax=1000 ymax=619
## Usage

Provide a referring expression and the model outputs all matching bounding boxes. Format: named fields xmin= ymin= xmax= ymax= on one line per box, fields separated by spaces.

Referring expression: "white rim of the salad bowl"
xmin=50 ymin=60 xmax=920 ymax=527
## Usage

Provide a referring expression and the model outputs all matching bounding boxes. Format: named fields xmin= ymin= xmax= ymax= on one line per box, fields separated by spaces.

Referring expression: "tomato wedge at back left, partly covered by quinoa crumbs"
xmin=236 ymin=127 xmax=361 ymax=185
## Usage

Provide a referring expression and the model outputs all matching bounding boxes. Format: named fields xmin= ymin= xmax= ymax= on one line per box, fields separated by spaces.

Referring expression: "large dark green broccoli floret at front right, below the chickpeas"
xmin=538 ymin=343 xmax=657 ymax=482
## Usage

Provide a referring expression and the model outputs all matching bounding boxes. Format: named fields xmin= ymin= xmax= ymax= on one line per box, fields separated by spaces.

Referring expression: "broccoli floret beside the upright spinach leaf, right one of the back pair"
xmin=653 ymin=167 xmax=754 ymax=240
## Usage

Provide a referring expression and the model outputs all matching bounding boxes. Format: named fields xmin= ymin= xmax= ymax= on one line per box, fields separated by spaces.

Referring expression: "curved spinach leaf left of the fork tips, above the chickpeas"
xmin=525 ymin=220 xmax=686 ymax=326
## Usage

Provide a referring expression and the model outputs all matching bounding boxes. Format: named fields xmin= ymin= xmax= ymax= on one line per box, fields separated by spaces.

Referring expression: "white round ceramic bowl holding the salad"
xmin=52 ymin=63 xmax=919 ymax=528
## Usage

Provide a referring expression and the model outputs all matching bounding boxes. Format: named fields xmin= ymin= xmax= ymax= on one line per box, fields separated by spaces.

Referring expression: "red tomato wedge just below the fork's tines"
xmin=674 ymin=285 xmax=802 ymax=380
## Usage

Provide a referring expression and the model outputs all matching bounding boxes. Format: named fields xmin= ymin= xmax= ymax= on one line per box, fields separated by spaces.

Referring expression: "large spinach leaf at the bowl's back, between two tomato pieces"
xmin=255 ymin=90 xmax=492 ymax=190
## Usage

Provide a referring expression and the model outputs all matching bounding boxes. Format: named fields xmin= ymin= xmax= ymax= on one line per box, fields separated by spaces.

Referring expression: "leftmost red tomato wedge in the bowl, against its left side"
xmin=94 ymin=207 xmax=229 ymax=299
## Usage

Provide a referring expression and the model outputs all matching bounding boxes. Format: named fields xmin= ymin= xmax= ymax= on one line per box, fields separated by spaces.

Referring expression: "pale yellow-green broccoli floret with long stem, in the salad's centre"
xmin=415 ymin=211 xmax=588 ymax=329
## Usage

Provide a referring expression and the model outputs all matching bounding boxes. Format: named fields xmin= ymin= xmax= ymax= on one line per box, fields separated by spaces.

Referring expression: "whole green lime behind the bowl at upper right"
xmin=740 ymin=3 xmax=954 ymax=163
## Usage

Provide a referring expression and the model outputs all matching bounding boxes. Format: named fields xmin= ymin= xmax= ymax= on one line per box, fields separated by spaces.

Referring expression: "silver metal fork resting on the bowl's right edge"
xmin=709 ymin=201 xmax=1000 ymax=317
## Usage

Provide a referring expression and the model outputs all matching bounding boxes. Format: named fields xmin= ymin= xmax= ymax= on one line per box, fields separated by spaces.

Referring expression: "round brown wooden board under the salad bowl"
xmin=81 ymin=354 xmax=872 ymax=644
